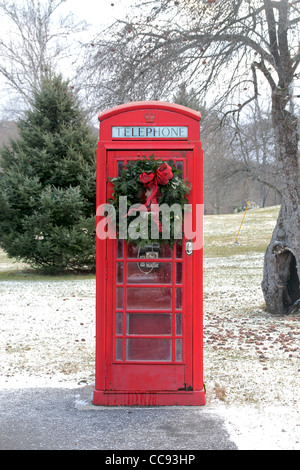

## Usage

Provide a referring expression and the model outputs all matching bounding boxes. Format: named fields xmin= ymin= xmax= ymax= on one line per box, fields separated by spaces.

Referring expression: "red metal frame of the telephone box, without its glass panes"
xmin=93 ymin=102 xmax=205 ymax=405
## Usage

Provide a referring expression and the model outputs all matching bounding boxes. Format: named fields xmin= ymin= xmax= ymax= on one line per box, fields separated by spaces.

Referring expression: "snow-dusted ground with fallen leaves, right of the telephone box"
xmin=204 ymin=253 xmax=300 ymax=450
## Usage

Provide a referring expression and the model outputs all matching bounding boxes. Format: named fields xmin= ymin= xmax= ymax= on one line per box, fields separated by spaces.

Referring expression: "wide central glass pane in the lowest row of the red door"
xmin=126 ymin=338 xmax=172 ymax=361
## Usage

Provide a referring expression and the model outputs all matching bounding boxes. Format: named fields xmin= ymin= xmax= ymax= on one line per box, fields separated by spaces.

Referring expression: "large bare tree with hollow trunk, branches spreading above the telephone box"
xmin=87 ymin=0 xmax=300 ymax=313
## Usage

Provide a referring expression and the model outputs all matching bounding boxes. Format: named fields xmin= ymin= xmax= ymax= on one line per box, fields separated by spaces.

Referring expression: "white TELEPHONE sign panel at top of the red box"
xmin=112 ymin=126 xmax=188 ymax=139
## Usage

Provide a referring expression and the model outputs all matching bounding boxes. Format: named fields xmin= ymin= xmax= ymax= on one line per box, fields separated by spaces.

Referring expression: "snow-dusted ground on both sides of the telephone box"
xmin=0 ymin=253 xmax=300 ymax=450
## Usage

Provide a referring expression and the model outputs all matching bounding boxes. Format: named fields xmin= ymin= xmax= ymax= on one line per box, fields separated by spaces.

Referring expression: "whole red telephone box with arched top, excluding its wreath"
xmin=93 ymin=101 xmax=205 ymax=405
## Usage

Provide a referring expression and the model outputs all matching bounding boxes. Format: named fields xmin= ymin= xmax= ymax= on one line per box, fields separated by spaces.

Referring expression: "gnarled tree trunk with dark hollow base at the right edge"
xmin=262 ymin=90 xmax=300 ymax=314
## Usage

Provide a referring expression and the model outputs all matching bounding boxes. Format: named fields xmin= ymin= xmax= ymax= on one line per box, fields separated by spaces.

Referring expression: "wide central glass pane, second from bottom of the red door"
xmin=127 ymin=313 xmax=172 ymax=335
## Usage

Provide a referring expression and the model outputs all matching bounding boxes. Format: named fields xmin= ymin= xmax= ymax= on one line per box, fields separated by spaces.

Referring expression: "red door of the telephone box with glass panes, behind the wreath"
xmin=105 ymin=150 xmax=193 ymax=392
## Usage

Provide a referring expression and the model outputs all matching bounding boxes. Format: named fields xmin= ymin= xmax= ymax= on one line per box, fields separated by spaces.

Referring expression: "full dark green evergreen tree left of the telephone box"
xmin=0 ymin=77 xmax=96 ymax=272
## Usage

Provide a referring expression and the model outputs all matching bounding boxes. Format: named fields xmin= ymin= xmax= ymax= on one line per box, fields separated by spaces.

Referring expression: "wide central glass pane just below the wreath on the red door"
xmin=127 ymin=260 xmax=172 ymax=284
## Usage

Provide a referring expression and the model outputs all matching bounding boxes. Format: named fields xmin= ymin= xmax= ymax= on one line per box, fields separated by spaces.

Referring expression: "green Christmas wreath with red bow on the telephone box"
xmin=109 ymin=155 xmax=191 ymax=246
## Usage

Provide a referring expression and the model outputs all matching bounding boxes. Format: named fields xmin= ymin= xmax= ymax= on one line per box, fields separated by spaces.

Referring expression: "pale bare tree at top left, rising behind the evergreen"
xmin=0 ymin=0 xmax=86 ymax=114
